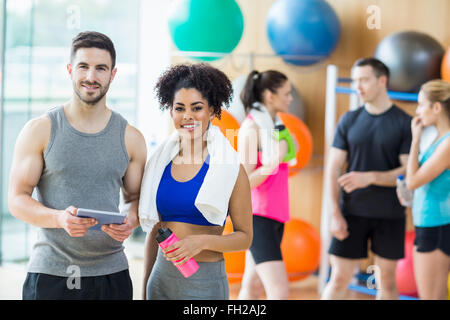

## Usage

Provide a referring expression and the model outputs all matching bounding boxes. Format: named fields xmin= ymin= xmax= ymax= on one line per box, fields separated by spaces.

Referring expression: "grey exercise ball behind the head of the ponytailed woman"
xmin=228 ymin=75 xmax=306 ymax=123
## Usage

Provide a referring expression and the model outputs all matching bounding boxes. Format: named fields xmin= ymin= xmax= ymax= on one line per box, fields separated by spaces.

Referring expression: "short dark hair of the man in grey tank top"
xmin=70 ymin=31 xmax=116 ymax=69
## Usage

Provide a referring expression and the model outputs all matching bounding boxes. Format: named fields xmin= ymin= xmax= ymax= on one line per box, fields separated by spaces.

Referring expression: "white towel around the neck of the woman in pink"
xmin=249 ymin=102 xmax=282 ymax=168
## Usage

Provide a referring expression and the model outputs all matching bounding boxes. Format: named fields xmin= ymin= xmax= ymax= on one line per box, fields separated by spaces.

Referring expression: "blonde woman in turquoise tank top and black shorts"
xmin=406 ymin=80 xmax=450 ymax=300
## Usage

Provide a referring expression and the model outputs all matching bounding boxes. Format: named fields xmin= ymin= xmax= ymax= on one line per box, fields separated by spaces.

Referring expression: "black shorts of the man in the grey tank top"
xmin=22 ymin=269 xmax=133 ymax=300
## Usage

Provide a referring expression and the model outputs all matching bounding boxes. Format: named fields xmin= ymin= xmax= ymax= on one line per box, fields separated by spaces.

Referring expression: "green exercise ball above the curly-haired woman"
xmin=169 ymin=0 xmax=244 ymax=61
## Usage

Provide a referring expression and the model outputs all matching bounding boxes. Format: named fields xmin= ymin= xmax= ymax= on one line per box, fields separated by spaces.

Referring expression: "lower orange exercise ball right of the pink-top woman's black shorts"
xmin=281 ymin=218 xmax=320 ymax=281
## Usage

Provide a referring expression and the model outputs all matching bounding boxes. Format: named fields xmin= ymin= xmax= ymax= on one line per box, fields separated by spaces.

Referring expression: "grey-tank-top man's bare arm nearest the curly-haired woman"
xmin=102 ymin=125 xmax=147 ymax=241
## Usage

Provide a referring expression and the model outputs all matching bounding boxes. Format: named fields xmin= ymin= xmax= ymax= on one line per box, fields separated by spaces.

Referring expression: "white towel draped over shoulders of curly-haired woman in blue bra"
xmin=139 ymin=125 xmax=240 ymax=232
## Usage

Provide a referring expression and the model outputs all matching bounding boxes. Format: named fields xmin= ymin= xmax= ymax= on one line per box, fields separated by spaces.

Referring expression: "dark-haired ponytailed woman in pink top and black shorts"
xmin=238 ymin=70 xmax=298 ymax=299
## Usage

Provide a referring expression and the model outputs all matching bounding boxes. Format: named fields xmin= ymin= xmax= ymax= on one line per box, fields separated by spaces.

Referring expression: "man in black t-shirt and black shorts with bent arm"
xmin=322 ymin=58 xmax=411 ymax=299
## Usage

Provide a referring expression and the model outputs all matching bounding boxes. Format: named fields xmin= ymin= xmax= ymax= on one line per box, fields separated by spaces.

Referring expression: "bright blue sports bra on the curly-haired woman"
xmin=156 ymin=155 xmax=221 ymax=226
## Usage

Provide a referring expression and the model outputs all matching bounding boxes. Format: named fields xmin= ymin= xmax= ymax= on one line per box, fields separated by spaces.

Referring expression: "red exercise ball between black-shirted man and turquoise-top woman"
xmin=395 ymin=231 xmax=417 ymax=296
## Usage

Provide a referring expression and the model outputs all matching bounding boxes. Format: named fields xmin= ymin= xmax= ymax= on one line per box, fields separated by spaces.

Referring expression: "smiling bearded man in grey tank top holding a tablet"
xmin=8 ymin=32 xmax=147 ymax=299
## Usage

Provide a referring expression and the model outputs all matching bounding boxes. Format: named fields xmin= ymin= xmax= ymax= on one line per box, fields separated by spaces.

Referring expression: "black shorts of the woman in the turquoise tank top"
xmin=414 ymin=224 xmax=450 ymax=256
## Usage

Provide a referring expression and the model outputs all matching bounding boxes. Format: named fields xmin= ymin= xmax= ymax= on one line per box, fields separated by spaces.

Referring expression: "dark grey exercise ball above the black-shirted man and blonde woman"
xmin=374 ymin=31 xmax=444 ymax=92
